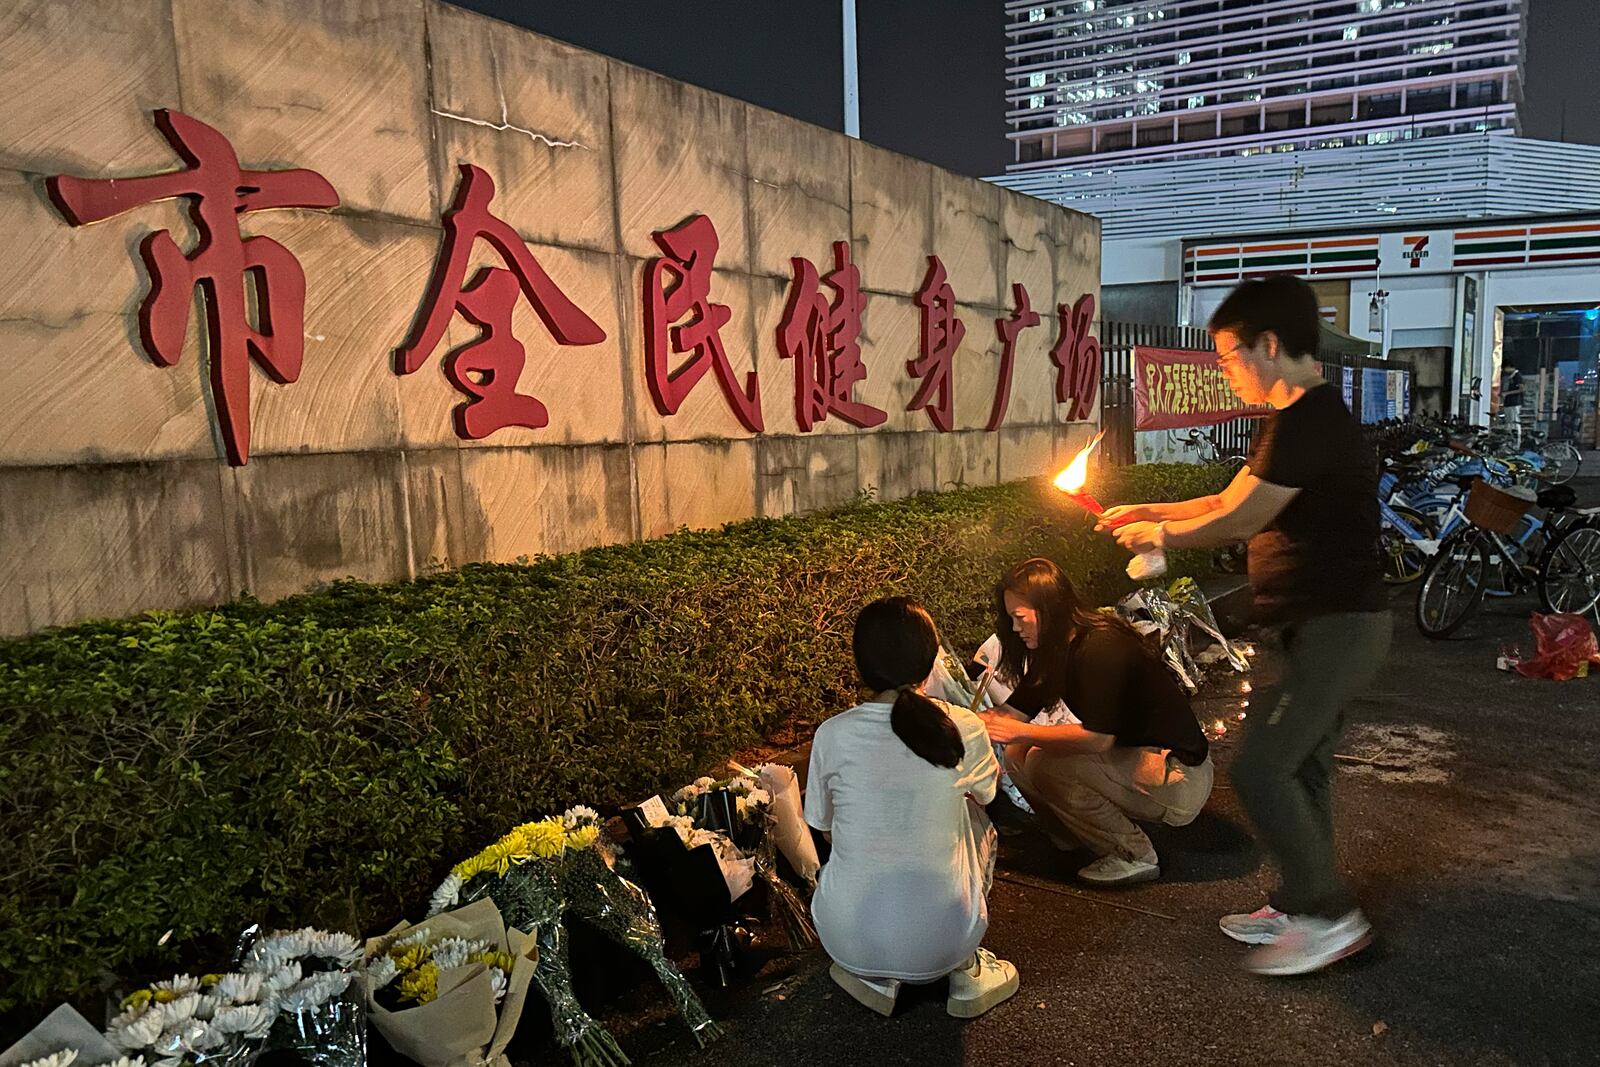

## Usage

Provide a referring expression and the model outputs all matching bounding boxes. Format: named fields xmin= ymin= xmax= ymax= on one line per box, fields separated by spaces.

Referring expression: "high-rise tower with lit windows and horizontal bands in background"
xmin=1005 ymin=0 xmax=1523 ymax=174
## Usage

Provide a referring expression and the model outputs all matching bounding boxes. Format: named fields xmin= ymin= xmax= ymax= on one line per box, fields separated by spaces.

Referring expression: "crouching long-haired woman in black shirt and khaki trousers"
xmin=984 ymin=560 xmax=1213 ymax=885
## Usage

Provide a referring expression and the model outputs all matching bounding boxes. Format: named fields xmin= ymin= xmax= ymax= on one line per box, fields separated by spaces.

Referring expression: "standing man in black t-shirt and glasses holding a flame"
xmin=1102 ymin=277 xmax=1394 ymax=974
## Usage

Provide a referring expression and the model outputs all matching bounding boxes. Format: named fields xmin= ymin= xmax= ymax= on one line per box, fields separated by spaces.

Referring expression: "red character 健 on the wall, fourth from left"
xmin=778 ymin=242 xmax=888 ymax=432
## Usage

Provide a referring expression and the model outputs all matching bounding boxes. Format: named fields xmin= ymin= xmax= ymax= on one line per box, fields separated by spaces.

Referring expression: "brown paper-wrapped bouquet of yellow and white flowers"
xmin=365 ymin=897 xmax=539 ymax=1067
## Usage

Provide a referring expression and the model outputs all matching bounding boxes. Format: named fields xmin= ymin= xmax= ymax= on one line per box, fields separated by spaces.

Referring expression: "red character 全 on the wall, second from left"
xmin=395 ymin=163 xmax=605 ymax=440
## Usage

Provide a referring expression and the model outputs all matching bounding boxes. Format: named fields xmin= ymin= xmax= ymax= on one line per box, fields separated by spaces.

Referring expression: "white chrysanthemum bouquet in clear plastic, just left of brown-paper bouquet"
xmin=233 ymin=926 xmax=366 ymax=1067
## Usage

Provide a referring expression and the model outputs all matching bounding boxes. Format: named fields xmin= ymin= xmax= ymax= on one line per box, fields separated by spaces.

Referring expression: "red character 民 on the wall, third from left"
xmin=645 ymin=214 xmax=762 ymax=434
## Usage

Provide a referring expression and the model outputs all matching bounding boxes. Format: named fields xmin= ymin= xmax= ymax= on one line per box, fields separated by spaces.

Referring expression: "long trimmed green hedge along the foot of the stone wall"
xmin=0 ymin=467 xmax=1219 ymax=1009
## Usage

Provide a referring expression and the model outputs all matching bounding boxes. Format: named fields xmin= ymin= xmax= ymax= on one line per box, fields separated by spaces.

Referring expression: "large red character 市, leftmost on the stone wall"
xmin=45 ymin=110 xmax=339 ymax=467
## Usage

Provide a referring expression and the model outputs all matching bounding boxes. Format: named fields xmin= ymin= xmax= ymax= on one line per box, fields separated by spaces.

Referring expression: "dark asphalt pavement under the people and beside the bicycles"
xmin=602 ymin=482 xmax=1600 ymax=1067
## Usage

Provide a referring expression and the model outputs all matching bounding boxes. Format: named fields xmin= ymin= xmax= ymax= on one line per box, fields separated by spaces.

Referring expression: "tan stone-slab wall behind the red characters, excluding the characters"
xmin=0 ymin=0 xmax=1099 ymax=633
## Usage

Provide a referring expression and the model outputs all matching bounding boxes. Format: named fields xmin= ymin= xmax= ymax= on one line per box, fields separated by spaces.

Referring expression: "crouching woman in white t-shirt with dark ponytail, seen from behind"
xmin=805 ymin=597 xmax=1018 ymax=1019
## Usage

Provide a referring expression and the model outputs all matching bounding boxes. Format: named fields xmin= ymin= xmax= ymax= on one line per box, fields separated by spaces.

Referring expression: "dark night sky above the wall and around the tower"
xmin=453 ymin=0 xmax=1600 ymax=178
